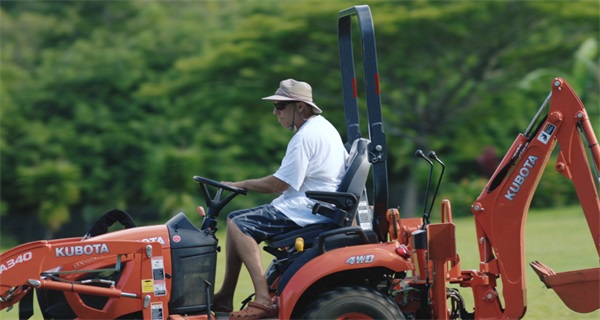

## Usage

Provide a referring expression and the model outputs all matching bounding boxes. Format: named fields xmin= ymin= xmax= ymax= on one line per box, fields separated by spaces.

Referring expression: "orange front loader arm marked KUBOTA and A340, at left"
xmin=0 ymin=238 xmax=162 ymax=316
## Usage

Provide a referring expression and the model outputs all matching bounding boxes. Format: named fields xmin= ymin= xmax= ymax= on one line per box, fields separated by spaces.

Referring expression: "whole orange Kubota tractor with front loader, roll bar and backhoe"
xmin=0 ymin=6 xmax=600 ymax=320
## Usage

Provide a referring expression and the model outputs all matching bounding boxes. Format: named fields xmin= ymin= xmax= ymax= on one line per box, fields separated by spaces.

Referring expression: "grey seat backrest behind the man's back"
xmin=337 ymin=138 xmax=371 ymax=196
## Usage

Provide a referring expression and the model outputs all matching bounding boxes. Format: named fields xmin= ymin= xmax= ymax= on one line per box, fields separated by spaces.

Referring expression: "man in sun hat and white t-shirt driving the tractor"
xmin=213 ymin=79 xmax=348 ymax=319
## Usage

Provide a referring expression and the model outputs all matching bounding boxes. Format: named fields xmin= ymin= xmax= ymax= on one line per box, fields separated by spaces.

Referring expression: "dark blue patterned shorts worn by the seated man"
xmin=228 ymin=204 xmax=301 ymax=243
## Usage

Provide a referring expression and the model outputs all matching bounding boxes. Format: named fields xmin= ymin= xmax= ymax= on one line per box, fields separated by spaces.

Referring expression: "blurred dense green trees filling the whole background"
xmin=0 ymin=0 xmax=600 ymax=241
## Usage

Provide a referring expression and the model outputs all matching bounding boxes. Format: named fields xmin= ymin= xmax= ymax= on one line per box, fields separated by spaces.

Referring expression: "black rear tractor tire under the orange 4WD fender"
xmin=302 ymin=286 xmax=405 ymax=320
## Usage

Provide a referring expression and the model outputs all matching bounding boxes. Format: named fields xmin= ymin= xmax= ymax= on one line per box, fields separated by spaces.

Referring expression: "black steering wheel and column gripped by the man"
xmin=194 ymin=176 xmax=248 ymax=232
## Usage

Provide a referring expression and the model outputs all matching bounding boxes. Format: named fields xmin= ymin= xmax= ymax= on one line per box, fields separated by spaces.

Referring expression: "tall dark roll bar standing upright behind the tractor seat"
xmin=338 ymin=5 xmax=388 ymax=241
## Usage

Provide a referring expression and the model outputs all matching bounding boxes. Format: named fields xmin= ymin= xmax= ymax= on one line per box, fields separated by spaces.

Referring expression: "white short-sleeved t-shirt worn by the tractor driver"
xmin=272 ymin=116 xmax=348 ymax=227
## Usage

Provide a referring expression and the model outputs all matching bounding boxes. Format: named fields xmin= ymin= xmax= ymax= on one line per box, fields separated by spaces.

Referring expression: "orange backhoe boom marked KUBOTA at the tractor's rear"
xmin=463 ymin=78 xmax=600 ymax=318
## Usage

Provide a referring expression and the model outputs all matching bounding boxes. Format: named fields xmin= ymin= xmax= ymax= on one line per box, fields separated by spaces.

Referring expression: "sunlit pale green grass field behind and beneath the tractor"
xmin=0 ymin=207 xmax=600 ymax=320
